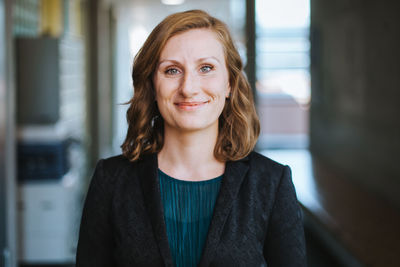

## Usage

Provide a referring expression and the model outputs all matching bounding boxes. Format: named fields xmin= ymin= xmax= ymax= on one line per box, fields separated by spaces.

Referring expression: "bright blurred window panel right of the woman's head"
xmin=256 ymin=0 xmax=311 ymax=149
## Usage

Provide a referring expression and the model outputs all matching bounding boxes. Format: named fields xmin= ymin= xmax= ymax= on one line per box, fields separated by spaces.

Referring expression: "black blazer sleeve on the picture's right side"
xmin=264 ymin=166 xmax=307 ymax=267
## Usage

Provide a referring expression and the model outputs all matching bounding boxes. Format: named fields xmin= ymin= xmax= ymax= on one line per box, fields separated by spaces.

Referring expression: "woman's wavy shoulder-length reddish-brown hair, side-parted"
xmin=121 ymin=10 xmax=260 ymax=161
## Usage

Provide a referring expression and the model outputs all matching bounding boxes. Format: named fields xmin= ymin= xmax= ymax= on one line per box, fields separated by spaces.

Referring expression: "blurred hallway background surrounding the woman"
xmin=0 ymin=0 xmax=400 ymax=267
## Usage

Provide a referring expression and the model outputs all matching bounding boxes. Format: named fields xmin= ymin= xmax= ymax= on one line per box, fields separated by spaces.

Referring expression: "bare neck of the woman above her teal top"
xmin=158 ymin=127 xmax=225 ymax=181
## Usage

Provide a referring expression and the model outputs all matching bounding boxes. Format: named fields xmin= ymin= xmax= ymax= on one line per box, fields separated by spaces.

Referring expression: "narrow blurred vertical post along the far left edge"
xmin=0 ymin=0 xmax=17 ymax=267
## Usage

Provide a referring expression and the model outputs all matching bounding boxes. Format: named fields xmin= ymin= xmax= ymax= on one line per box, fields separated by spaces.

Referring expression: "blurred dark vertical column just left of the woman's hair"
xmin=87 ymin=0 xmax=112 ymax=169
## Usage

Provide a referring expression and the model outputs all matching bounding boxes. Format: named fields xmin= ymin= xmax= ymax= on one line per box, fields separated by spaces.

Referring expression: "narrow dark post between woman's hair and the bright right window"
xmin=245 ymin=0 xmax=256 ymax=96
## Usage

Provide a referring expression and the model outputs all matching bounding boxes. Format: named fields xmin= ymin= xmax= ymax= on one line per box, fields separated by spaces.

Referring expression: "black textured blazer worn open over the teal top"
xmin=76 ymin=152 xmax=306 ymax=267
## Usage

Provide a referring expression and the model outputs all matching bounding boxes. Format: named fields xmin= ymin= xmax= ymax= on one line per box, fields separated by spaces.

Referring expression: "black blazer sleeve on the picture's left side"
xmin=76 ymin=160 xmax=115 ymax=267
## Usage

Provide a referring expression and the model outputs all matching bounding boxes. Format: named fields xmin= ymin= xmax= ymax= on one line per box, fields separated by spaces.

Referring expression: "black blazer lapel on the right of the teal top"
xmin=199 ymin=157 xmax=249 ymax=266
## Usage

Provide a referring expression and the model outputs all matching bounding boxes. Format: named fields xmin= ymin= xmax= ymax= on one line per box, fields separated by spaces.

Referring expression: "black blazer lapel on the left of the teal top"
xmin=138 ymin=154 xmax=173 ymax=266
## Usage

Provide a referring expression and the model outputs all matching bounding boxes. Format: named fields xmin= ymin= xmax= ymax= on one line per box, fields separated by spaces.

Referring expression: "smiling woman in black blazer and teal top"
xmin=77 ymin=10 xmax=305 ymax=266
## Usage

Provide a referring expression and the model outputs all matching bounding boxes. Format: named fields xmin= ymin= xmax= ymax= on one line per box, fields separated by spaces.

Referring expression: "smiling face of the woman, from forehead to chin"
xmin=153 ymin=29 xmax=230 ymax=134
